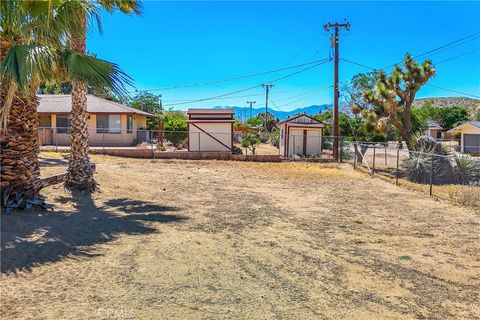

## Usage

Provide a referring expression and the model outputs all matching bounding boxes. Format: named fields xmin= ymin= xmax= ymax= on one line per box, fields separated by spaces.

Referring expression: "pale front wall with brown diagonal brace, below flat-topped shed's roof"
xmin=188 ymin=122 xmax=232 ymax=152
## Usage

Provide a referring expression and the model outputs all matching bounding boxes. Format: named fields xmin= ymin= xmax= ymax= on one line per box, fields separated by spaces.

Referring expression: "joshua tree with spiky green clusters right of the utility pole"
xmin=351 ymin=54 xmax=435 ymax=149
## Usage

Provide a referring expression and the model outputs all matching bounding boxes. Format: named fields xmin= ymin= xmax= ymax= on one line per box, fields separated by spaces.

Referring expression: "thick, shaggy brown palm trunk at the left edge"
xmin=0 ymin=85 xmax=41 ymax=200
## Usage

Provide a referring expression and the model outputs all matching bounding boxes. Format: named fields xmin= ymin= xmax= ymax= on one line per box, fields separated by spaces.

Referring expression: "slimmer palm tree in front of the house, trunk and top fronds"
xmin=65 ymin=0 xmax=140 ymax=192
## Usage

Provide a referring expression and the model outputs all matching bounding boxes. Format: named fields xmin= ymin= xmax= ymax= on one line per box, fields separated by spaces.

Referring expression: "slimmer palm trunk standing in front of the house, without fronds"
xmin=65 ymin=11 xmax=97 ymax=192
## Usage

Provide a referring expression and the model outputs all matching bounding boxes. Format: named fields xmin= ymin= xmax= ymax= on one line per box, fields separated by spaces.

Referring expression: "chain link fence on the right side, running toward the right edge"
xmin=344 ymin=142 xmax=480 ymax=207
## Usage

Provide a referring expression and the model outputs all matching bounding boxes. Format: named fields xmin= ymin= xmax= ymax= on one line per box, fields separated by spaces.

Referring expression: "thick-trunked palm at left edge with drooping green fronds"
xmin=0 ymin=0 xmax=129 ymax=211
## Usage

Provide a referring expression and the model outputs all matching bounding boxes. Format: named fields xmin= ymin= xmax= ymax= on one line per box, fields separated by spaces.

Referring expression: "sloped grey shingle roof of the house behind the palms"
xmin=37 ymin=94 xmax=155 ymax=117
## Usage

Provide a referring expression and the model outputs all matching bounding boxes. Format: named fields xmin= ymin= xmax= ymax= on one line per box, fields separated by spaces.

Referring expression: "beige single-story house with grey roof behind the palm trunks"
xmin=37 ymin=94 xmax=154 ymax=147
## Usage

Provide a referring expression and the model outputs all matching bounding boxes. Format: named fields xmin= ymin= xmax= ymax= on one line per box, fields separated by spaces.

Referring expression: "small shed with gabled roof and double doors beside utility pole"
xmin=279 ymin=114 xmax=325 ymax=158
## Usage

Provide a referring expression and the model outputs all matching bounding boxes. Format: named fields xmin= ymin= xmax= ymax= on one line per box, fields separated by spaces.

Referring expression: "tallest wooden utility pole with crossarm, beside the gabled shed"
xmin=323 ymin=22 xmax=350 ymax=161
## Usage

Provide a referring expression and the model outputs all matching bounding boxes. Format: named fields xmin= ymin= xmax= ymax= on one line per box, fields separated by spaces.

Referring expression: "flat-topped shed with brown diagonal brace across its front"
xmin=187 ymin=109 xmax=234 ymax=152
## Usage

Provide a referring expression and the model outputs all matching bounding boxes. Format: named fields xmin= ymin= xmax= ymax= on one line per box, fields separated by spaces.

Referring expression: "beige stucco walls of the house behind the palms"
xmin=42 ymin=114 xmax=147 ymax=147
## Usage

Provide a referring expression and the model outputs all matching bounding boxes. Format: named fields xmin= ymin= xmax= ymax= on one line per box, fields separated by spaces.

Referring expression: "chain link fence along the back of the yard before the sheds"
xmin=39 ymin=127 xmax=345 ymax=161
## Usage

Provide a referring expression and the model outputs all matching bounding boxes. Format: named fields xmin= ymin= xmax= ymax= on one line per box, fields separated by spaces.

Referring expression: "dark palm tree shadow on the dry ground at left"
xmin=1 ymin=193 xmax=186 ymax=273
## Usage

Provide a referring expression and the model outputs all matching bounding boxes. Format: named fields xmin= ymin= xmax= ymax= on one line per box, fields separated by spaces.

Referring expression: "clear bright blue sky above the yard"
xmin=87 ymin=1 xmax=480 ymax=110
